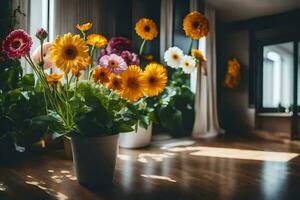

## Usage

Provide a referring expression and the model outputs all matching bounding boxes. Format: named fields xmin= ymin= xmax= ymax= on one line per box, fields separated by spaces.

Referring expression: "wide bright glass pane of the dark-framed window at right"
xmin=262 ymin=42 xmax=293 ymax=112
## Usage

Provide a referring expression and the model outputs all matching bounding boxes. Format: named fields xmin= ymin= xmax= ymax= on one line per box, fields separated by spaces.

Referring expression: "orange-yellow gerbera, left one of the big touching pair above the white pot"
xmin=120 ymin=65 xmax=145 ymax=102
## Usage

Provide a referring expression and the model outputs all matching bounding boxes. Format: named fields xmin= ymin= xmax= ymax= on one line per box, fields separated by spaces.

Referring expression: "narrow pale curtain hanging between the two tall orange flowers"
xmin=160 ymin=0 xmax=173 ymax=62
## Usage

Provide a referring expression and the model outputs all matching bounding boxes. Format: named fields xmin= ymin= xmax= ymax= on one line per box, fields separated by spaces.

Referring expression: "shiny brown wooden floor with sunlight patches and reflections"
xmin=0 ymin=139 xmax=300 ymax=200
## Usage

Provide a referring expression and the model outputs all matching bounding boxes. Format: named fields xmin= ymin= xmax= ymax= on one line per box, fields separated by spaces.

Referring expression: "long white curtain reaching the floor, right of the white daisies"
xmin=192 ymin=5 xmax=221 ymax=138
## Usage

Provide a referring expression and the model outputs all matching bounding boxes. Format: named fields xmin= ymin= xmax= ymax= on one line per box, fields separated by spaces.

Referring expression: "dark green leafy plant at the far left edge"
xmin=0 ymin=55 xmax=48 ymax=162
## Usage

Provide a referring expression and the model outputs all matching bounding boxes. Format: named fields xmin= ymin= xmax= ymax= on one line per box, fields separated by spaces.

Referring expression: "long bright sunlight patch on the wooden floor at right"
xmin=167 ymin=146 xmax=299 ymax=162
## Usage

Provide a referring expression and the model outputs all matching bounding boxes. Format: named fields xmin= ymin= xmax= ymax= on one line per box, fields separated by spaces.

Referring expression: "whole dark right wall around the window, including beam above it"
xmin=217 ymin=10 xmax=300 ymax=134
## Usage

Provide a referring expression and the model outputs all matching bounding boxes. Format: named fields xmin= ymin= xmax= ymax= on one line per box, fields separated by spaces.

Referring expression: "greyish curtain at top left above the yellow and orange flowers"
xmin=50 ymin=0 xmax=116 ymax=38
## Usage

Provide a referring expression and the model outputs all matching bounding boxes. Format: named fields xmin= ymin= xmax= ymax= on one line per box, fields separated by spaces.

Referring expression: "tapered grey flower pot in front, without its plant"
xmin=71 ymin=135 xmax=119 ymax=187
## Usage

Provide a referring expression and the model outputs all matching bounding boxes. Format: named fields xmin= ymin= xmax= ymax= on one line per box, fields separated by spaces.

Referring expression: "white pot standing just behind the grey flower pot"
xmin=119 ymin=123 xmax=152 ymax=149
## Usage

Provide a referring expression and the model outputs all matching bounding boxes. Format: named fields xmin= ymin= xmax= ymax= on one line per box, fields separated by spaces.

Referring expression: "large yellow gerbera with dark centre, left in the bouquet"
xmin=50 ymin=33 xmax=89 ymax=73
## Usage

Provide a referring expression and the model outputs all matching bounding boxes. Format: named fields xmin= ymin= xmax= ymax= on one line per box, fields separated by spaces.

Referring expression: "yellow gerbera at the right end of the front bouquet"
xmin=143 ymin=63 xmax=168 ymax=97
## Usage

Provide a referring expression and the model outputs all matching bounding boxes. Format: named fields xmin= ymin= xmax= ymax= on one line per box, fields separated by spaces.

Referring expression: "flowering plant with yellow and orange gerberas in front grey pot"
xmin=3 ymin=20 xmax=169 ymax=186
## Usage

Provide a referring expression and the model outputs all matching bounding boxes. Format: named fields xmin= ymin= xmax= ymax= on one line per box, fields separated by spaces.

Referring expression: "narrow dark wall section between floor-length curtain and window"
xmin=217 ymin=24 xmax=254 ymax=134
